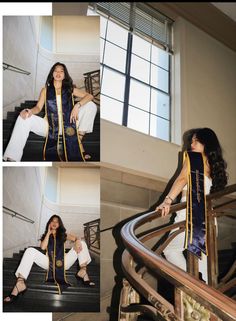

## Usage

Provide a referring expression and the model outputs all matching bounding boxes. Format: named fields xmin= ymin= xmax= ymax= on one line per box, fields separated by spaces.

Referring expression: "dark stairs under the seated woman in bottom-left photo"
xmin=3 ymin=247 xmax=100 ymax=312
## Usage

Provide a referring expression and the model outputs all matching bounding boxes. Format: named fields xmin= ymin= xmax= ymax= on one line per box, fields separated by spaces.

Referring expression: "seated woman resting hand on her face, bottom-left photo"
xmin=4 ymin=215 xmax=95 ymax=304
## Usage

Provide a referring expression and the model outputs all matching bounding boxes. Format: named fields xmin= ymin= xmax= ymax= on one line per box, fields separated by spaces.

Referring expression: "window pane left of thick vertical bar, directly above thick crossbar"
xmin=104 ymin=41 xmax=126 ymax=72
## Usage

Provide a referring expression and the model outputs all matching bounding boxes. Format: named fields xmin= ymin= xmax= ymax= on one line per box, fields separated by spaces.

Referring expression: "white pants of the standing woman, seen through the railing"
xmin=163 ymin=210 xmax=208 ymax=283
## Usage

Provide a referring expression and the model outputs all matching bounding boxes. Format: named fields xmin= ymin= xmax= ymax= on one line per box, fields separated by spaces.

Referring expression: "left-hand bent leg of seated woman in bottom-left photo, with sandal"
xmin=4 ymin=247 xmax=49 ymax=303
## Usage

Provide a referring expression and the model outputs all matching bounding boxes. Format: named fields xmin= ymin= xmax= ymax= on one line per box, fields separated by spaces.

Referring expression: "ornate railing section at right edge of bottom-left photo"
xmin=84 ymin=219 xmax=100 ymax=254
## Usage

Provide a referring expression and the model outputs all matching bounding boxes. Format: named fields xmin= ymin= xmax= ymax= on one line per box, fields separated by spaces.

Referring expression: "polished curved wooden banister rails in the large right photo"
xmin=121 ymin=184 xmax=236 ymax=321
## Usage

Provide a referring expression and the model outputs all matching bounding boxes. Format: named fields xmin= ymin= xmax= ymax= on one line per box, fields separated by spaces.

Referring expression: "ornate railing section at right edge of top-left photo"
xmin=83 ymin=70 xmax=100 ymax=106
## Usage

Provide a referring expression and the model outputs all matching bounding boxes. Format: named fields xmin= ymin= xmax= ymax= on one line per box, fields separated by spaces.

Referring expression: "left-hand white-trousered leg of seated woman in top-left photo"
xmin=3 ymin=115 xmax=48 ymax=162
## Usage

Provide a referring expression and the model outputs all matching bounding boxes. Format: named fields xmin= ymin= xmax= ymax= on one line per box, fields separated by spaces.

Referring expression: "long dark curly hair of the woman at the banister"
xmin=189 ymin=127 xmax=228 ymax=193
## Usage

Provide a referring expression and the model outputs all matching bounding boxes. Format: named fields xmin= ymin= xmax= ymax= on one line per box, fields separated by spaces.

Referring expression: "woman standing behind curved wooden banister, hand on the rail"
xmin=156 ymin=128 xmax=227 ymax=282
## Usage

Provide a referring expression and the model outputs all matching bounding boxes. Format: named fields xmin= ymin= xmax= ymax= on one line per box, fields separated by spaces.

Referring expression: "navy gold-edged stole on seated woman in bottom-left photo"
xmin=46 ymin=234 xmax=70 ymax=294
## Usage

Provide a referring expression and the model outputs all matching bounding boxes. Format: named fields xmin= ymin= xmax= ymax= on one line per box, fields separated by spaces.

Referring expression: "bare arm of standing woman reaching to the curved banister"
xmin=156 ymin=161 xmax=187 ymax=216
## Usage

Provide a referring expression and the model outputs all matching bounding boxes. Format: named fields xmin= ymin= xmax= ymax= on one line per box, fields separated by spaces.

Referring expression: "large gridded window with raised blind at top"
xmin=91 ymin=2 xmax=171 ymax=141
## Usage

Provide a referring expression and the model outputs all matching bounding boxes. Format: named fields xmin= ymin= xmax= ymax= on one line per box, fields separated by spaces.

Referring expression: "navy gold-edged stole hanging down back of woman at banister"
xmin=184 ymin=152 xmax=207 ymax=258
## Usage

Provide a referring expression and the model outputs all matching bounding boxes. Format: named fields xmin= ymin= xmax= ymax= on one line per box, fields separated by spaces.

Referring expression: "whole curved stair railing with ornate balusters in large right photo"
xmin=119 ymin=184 xmax=236 ymax=321
